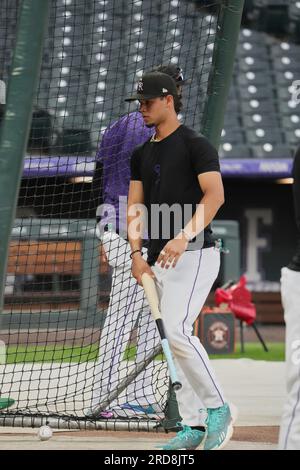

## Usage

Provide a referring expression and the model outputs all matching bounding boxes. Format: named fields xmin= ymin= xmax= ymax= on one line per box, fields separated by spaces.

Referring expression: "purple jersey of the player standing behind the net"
xmin=96 ymin=111 xmax=154 ymax=233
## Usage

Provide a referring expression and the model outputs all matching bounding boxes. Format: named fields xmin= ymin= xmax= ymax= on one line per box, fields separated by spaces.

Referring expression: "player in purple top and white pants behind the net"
xmin=86 ymin=64 xmax=192 ymax=418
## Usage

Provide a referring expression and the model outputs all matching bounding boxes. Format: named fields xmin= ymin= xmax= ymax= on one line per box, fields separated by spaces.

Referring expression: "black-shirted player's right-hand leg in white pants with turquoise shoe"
xmin=153 ymin=248 xmax=232 ymax=448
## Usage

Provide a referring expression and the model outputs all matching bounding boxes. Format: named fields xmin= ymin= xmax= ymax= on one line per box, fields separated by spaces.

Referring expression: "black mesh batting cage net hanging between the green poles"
xmin=0 ymin=0 xmax=225 ymax=429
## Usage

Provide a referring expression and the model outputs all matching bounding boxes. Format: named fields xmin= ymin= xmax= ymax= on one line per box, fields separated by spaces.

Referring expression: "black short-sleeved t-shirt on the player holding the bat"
xmin=131 ymin=125 xmax=220 ymax=264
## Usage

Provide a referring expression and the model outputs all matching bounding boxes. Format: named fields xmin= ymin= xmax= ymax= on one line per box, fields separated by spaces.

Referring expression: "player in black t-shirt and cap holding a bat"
xmin=127 ymin=72 xmax=233 ymax=450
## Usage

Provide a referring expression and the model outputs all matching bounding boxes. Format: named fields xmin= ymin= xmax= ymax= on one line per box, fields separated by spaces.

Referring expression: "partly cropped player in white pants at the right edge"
xmin=279 ymin=147 xmax=300 ymax=450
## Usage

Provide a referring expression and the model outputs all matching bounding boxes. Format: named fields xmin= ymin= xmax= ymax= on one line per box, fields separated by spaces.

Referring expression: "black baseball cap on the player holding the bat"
xmin=125 ymin=72 xmax=178 ymax=101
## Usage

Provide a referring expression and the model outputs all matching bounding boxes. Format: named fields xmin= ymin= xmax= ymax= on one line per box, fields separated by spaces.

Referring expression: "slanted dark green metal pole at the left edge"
xmin=0 ymin=0 xmax=50 ymax=312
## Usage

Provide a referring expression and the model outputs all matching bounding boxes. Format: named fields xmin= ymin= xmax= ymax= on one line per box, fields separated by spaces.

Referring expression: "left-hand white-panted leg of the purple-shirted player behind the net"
xmin=91 ymin=232 xmax=143 ymax=408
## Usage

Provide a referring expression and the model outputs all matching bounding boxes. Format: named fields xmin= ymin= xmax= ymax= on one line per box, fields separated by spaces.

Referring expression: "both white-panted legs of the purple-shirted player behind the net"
xmin=91 ymin=232 xmax=158 ymax=416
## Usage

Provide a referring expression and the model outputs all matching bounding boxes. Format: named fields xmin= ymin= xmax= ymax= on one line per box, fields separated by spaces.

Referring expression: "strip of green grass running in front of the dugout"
xmin=6 ymin=343 xmax=284 ymax=364
